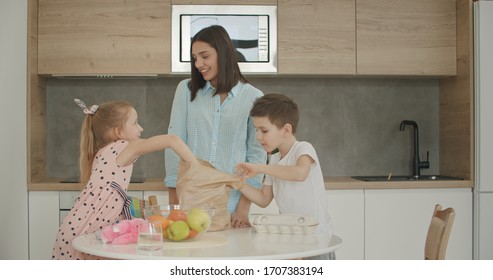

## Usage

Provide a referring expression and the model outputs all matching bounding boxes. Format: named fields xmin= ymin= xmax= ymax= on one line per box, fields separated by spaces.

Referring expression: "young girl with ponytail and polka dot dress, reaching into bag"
xmin=53 ymin=99 xmax=197 ymax=259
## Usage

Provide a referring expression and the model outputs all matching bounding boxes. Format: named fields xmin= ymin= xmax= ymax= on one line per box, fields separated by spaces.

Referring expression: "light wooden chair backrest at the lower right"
xmin=425 ymin=204 xmax=455 ymax=260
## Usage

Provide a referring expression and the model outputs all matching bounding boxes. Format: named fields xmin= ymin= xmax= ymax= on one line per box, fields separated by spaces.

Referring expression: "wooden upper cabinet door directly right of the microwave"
xmin=277 ymin=0 xmax=356 ymax=75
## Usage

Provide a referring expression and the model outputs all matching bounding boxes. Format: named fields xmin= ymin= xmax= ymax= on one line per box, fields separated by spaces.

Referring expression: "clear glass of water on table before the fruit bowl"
xmin=137 ymin=221 xmax=163 ymax=250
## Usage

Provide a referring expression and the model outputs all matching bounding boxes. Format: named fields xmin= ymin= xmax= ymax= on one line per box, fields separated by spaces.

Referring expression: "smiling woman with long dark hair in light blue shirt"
xmin=164 ymin=25 xmax=267 ymax=227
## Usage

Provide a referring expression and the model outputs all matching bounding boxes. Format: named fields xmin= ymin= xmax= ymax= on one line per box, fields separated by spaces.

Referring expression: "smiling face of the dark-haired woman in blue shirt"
xmin=192 ymin=41 xmax=218 ymax=87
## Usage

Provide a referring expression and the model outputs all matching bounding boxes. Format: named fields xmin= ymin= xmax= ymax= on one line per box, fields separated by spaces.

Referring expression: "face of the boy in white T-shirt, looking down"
xmin=253 ymin=117 xmax=285 ymax=152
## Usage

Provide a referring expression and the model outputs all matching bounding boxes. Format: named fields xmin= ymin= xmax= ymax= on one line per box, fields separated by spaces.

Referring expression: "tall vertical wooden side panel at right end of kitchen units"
xmin=440 ymin=0 xmax=474 ymax=180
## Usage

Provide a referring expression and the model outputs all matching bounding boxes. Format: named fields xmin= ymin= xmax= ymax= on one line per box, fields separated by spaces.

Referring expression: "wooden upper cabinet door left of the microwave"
xmin=38 ymin=0 xmax=171 ymax=75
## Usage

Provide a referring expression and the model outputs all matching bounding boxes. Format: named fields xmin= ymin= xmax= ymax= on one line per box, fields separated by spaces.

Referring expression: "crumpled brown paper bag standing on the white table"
xmin=176 ymin=160 xmax=241 ymax=231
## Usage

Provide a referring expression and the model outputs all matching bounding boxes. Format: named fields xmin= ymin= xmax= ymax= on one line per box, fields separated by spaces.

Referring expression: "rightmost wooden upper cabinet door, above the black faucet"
xmin=356 ymin=0 xmax=457 ymax=76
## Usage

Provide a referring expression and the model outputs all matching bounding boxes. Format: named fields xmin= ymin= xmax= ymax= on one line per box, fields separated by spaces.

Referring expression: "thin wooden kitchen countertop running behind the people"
xmin=28 ymin=177 xmax=474 ymax=191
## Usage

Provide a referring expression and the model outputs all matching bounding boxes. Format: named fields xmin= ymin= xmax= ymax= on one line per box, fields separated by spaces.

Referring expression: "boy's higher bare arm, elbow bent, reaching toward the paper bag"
xmin=235 ymin=155 xmax=314 ymax=182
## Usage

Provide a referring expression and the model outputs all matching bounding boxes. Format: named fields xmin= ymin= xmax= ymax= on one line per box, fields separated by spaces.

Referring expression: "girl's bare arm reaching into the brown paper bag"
xmin=116 ymin=134 xmax=198 ymax=166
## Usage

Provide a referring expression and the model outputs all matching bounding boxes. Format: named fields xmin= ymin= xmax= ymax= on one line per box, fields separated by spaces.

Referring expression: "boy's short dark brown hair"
xmin=250 ymin=93 xmax=300 ymax=134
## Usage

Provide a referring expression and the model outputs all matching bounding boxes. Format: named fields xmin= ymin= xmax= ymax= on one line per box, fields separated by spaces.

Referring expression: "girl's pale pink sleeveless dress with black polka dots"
xmin=53 ymin=140 xmax=133 ymax=260
